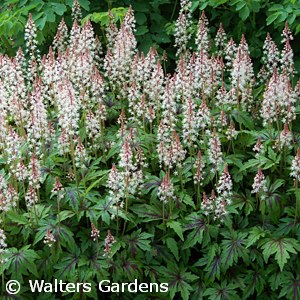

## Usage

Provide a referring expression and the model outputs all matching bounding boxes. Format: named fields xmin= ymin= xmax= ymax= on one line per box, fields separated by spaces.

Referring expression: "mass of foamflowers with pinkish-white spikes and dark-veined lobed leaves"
xmin=0 ymin=1 xmax=300 ymax=299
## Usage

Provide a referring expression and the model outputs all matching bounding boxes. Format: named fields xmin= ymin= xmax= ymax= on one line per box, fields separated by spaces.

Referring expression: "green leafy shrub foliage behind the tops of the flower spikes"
xmin=0 ymin=0 xmax=300 ymax=70
